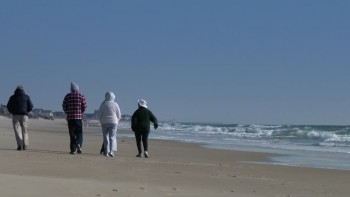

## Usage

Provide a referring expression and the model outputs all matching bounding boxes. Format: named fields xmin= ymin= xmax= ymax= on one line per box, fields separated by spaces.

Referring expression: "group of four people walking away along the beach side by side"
xmin=7 ymin=82 xmax=158 ymax=158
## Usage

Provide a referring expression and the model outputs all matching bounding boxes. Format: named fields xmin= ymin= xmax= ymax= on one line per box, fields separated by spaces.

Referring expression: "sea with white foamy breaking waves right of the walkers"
xmin=127 ymin=122 xmax=350 ymax=156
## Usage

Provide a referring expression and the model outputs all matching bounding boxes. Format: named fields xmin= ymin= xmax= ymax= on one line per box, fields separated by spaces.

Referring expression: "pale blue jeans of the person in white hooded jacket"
xmin=101 ymin=123 xmax=118 ymax=154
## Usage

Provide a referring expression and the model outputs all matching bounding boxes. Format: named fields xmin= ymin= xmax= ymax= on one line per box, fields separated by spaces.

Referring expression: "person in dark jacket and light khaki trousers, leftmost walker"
xmin=7 ymin=85 xmax=33 ymax=151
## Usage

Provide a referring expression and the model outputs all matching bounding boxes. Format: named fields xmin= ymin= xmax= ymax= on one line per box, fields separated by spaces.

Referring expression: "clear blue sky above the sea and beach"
xmin=0 ymin=0 xmax=350 ymax=125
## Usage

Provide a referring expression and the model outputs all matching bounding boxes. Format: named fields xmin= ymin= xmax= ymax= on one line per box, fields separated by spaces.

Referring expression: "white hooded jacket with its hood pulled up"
xmin=99 ymin=92 xmax=121 ymax=124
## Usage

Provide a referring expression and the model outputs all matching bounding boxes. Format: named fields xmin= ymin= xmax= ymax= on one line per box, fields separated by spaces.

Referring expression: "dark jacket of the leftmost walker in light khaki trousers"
xmin=7 ymin=89 xmax=34 ymax=116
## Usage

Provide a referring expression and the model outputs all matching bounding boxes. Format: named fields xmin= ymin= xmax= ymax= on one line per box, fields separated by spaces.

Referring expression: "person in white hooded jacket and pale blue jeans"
xmin=99 ymin=92 xmax=121 ymax=157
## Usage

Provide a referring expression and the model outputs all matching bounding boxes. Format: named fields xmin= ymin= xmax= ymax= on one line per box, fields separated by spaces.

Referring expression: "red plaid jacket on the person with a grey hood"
xmin=62 ymin=92 xmax=87 ymax=120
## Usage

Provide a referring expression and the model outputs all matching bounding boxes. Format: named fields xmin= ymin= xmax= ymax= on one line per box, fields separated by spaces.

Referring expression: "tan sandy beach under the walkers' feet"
xmin=0 ymin=117 xmax=350 ymax=197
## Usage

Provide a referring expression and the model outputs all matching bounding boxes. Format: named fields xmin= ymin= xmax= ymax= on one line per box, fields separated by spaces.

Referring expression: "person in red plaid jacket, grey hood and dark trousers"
xmin=62 ymin=82 xmax=87 ymax=154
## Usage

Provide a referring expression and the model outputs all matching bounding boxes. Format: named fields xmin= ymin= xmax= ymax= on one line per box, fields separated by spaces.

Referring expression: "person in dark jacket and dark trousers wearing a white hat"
xmin=131 ymin=99 xmax=158 ymax=158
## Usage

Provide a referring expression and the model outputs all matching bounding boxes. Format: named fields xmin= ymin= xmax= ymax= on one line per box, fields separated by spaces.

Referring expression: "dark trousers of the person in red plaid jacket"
xmin=68 ymin=119 xmax=83 ymax=152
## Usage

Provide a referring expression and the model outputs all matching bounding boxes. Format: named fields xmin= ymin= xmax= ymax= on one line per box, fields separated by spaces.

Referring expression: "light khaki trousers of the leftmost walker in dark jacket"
xmin=12 ymin=115 xmax=29 ymax=146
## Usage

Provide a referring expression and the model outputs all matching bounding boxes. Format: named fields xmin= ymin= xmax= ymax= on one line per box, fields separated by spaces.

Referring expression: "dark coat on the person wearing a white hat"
xmin=131 ymin=106 xmax=158 ymax=133
